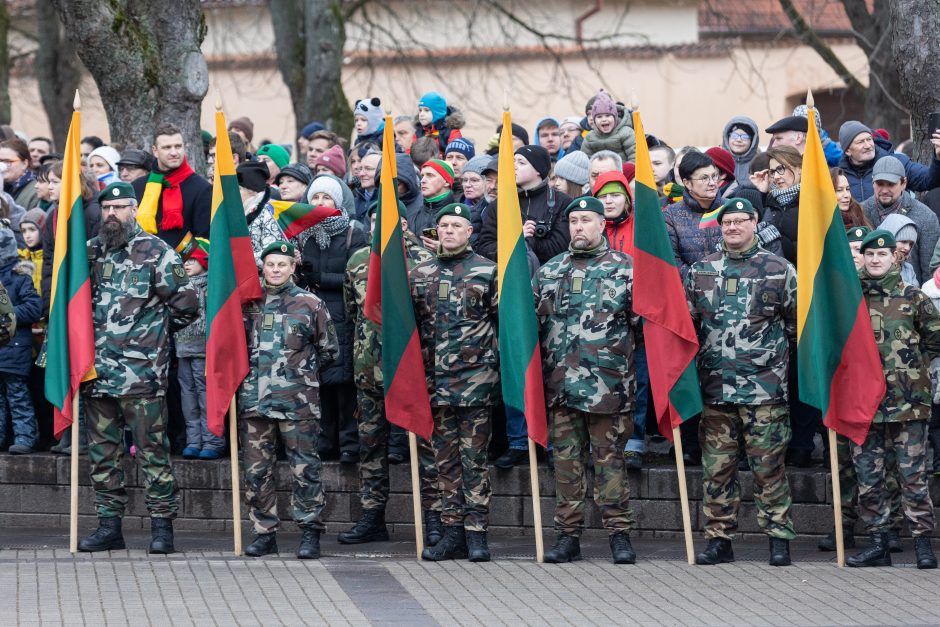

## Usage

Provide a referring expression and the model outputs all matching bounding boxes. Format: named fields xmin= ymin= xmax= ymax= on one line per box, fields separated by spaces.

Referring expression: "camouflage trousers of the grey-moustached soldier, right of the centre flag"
xmin=549 ymin=407 xmax=636 ymax=536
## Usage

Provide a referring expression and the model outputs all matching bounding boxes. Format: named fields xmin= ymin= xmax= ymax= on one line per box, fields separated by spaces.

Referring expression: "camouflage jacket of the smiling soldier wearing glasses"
xmin=685 ymin=241 xmax=796 ymax=405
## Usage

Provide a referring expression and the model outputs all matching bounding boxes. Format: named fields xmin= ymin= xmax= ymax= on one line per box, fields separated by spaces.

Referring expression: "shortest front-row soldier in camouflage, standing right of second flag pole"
xmin=238 ymin=240 xmax=339 ymax=559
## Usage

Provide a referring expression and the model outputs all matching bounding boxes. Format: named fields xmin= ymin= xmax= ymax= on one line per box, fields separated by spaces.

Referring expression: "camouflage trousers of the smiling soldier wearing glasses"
xmin=698 ymin=404 xmax=796 ymax=540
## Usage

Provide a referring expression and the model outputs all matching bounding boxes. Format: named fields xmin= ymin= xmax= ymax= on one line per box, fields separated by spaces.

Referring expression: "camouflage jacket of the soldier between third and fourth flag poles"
xmin=410 ymin=246 xmax=500 ymax=407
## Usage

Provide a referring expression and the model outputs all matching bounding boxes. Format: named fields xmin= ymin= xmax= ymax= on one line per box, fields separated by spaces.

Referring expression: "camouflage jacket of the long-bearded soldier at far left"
xmin=87 ymin=224 xmax=199 ymax=398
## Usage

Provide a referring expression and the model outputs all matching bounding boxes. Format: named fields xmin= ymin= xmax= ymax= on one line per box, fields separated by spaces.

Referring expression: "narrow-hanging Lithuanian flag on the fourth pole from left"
xmin=496 ymin=111 xmax=548 ymax=447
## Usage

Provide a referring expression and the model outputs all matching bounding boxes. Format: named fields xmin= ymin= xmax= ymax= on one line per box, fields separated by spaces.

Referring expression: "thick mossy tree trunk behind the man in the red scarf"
xmin=52 ymin=0 xmax=209 ymax=171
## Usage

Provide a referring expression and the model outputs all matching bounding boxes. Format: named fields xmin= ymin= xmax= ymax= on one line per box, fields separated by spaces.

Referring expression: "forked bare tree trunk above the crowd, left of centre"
xmin=270 ymin=0 xmax=352 ymax=150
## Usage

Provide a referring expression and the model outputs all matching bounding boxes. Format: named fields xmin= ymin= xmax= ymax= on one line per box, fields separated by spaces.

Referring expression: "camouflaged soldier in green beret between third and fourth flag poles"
xmin=410 ymin=203 xmax=500 ymax=562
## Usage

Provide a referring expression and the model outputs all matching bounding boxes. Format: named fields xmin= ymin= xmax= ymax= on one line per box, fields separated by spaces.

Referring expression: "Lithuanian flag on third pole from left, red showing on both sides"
xmin=364 ymin=116 xmax=434 ymax=440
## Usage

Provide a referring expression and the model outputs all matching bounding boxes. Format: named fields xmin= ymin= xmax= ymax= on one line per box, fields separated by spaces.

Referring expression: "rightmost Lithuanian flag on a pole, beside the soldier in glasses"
xmin=796 ymin=103 xmax=885 ymax=444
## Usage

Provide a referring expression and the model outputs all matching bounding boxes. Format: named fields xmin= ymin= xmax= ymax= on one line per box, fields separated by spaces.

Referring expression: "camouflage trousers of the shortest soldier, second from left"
xmin=239 ymin=416 xmax=326 ymax=534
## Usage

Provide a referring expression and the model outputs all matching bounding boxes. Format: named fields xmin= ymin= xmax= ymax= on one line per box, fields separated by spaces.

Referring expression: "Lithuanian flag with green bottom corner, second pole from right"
xmin=633 ymin=111 xmax=702 ymax=440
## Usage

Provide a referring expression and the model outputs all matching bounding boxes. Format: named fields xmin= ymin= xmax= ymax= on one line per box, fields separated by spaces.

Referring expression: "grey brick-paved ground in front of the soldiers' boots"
xmin=0 ymin=529 xmax=940 ymax=626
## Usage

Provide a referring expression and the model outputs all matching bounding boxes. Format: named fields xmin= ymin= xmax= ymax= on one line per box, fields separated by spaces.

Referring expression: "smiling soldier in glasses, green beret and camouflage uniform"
xmin=685 ymin=198 xmax=796 ymax=566
